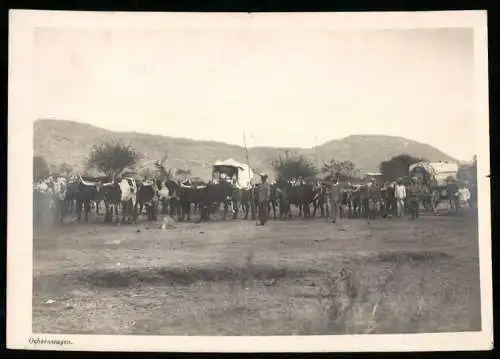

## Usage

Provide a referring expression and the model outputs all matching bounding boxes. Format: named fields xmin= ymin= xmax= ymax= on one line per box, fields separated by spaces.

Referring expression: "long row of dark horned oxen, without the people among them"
xmin=35 ymin=176 xmax=395 ymax=228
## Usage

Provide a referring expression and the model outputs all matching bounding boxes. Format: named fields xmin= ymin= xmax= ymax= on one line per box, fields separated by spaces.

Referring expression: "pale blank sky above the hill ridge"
xmin=34 ymin=28 xmax=476 ymax=160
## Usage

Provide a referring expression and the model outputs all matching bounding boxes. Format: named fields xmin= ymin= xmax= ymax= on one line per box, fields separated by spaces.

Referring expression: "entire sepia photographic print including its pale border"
xmin=7 ymin=10 xmax=493 ymax=351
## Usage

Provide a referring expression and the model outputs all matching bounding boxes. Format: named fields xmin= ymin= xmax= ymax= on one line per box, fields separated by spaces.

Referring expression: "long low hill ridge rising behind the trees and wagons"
xmin=34 ymin=119 xmax=454 ymax=178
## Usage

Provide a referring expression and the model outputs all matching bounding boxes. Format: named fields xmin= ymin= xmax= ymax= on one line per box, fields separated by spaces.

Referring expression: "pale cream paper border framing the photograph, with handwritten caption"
xmin=7 ymin=10 xmax=493 ymax=352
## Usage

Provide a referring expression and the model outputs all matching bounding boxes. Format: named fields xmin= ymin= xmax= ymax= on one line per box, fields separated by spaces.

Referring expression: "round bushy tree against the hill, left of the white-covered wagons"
xmin=88 ymin=142 xmax=139 ymax=177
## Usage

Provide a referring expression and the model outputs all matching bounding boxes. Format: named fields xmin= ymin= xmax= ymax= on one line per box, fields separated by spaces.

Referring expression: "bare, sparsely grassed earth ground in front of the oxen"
xmin=33 ymin=210 xmax=481 ymax=335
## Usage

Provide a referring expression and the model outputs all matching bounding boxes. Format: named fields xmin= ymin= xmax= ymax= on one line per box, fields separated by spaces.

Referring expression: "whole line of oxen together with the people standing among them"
xmin=34 ymin=161 xmax=475 ymax=225
